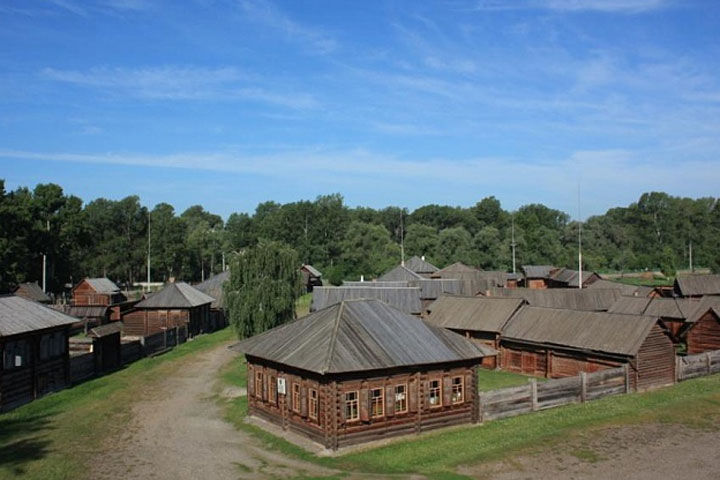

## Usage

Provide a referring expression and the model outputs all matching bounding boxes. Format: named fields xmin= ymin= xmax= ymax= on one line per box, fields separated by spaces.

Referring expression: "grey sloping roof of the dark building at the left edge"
xmin=0 ymin=295 xmax=77 ymax=337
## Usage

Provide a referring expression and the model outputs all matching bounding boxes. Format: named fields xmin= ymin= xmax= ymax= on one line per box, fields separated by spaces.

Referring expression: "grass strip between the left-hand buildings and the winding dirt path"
xmin=0 ymin=328 xmax=235 ymax=480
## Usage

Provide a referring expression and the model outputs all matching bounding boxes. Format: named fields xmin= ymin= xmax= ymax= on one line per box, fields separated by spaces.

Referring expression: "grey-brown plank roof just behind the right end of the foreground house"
xmin=427 ymin=296 xmax=525 ymax=333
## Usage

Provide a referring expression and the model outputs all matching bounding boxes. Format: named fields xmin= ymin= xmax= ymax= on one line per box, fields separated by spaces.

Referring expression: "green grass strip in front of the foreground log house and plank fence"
xmin=218 ymin=361 xmax=720 ymax=478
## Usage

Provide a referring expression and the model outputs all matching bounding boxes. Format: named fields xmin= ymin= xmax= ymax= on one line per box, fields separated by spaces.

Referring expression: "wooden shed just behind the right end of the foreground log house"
xmin=427 ymin=296 xmax=525 ymax=368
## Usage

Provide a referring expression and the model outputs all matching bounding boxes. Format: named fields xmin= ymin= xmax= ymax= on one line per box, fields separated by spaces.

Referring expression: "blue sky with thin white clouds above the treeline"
xmin=0 ymin=0 xmax=720 ymax=217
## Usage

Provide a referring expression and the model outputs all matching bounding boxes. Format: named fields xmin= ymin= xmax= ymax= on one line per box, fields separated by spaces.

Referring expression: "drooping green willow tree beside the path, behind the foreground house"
xmin=224 ymin=242 xmax=301 ymax=338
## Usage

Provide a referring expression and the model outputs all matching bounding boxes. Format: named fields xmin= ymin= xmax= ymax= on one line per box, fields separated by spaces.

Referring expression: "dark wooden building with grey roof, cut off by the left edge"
xmin=0 ymin=295 xmax=75 ymax=411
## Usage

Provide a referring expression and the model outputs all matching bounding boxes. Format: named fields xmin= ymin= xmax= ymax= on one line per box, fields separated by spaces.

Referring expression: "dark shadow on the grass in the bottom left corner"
xmin=0 ymin=413 xmax=52 ymax=476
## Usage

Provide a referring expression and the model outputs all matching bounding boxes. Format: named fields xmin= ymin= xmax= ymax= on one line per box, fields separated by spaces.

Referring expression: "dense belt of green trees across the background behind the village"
xmin=0 ymin=180 xmax=720 ymax=292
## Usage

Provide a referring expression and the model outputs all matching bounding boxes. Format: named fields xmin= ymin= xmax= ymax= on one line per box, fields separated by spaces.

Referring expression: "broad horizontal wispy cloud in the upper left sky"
xmin=42 ymin=66 xmax=318 ymax=109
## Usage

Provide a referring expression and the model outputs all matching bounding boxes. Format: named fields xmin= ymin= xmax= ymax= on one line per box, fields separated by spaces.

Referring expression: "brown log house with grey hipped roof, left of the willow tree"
xmin=123 ymin=282 xmax=214 ymax=336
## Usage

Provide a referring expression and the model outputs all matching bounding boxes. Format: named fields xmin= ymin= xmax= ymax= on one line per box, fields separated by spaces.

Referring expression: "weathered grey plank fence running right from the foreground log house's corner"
xmin=479 ymin=365 xmax=630 ymax=422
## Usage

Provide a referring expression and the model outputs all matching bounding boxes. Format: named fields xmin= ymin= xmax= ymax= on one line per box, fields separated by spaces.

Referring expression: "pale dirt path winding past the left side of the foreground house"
xmin=91 ymin=345 xmax=333 ymax=480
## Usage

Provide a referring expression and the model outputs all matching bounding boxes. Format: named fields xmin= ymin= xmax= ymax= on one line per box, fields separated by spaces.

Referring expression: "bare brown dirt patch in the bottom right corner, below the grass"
xmin=459 ymin=425 xmax=720 ymax=480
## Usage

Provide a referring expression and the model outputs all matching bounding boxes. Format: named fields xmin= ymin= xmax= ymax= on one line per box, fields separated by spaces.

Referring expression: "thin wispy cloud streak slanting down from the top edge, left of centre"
xmin=240 ymin=0 xmax=338 ymax=54
